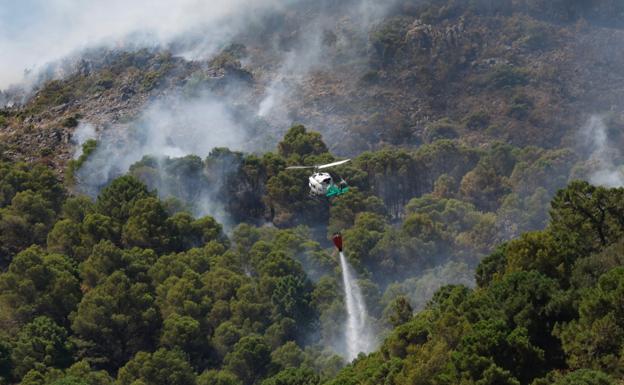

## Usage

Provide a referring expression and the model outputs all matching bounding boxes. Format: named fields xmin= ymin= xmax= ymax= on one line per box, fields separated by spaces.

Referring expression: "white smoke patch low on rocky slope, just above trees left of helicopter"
xmin=77 ymin=93 xmax=258 ymax=225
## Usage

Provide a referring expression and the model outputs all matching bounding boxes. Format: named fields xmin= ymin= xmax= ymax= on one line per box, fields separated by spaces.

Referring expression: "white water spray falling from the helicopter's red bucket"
xmin=340 ymin=251 xmax=374 ymax=361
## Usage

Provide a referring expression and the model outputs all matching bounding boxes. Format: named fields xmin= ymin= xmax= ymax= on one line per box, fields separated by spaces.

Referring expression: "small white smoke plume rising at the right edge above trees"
xmin=582 ymin=116 xmax=624 ymax=187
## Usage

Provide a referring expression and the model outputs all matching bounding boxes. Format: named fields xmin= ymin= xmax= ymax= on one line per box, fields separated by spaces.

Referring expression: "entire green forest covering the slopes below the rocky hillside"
xmin=0 ymin=126 xmax=624 ymax=385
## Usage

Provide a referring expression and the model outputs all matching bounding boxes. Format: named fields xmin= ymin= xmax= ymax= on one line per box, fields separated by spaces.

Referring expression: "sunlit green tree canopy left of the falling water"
xmin=0 ymin=154 xmax=341 ymax=384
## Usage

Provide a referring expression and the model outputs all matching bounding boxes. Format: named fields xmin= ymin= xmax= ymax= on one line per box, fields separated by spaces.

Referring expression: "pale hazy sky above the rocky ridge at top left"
xmin=0 ymin=0 xmax=289 ymax=89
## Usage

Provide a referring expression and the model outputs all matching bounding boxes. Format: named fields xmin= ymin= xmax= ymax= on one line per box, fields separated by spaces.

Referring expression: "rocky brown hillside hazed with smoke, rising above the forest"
xmin=2 ymin=1 xmax=624 ymax=166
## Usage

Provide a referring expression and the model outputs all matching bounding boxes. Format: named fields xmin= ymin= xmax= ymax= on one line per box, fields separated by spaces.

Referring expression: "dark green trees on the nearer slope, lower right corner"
xmin=330 ymin=178 xmax=624 ymax=384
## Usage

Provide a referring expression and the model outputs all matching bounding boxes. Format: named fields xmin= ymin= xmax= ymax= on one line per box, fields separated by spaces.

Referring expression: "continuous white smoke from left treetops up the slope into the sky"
xmin=8 ymin=0 xmax=400 ymax=222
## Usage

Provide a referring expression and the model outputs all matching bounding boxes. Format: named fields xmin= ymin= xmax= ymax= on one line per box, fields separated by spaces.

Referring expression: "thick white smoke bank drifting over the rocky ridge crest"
xmin=0 ymin=0 xmax=392 ymax=90
